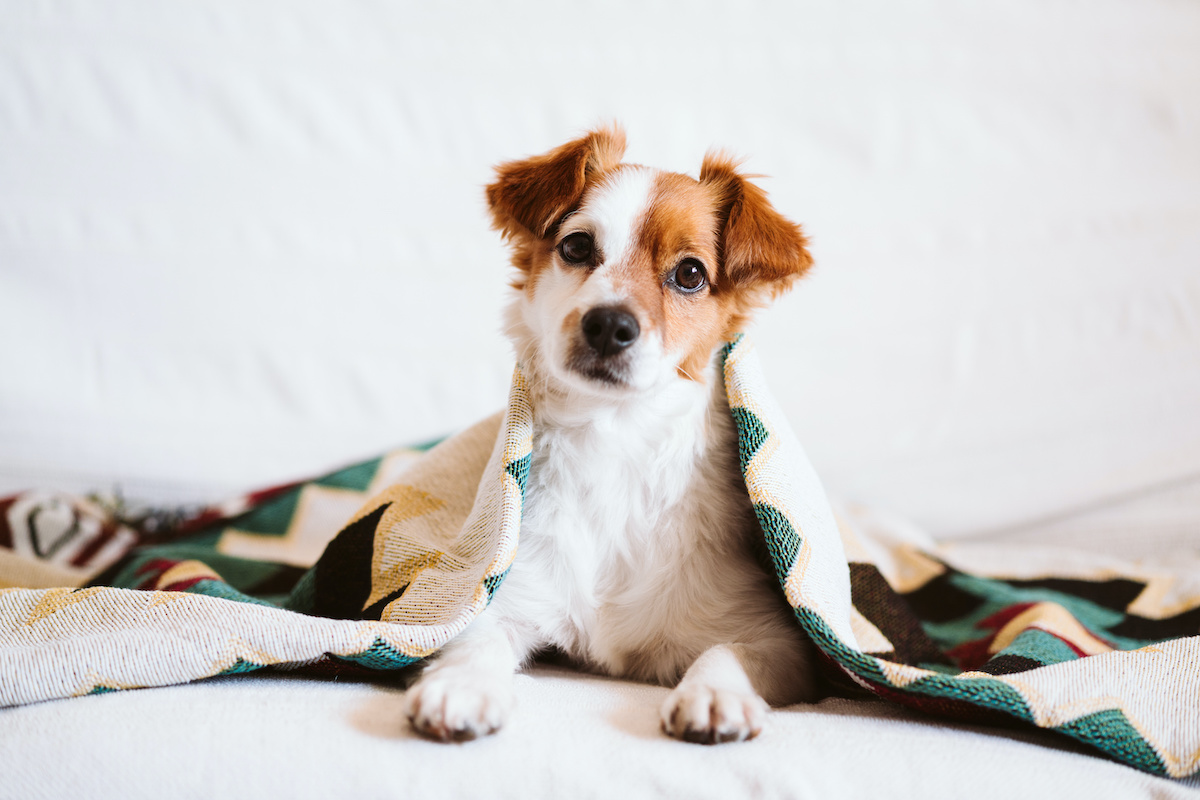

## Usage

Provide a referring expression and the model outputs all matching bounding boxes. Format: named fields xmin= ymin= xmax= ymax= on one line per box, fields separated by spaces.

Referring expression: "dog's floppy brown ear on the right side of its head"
xmin=700 ymin=152 xmax=812 ymax=291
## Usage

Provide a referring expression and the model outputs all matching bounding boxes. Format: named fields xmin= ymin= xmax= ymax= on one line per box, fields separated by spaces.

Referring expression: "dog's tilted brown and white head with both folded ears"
xmin=487 ymin=128 xmax=811 ymax=392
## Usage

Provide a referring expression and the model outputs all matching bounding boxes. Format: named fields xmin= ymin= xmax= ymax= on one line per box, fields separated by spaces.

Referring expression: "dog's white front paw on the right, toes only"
xmin=662 ymin=684 xmax=768 ymax=745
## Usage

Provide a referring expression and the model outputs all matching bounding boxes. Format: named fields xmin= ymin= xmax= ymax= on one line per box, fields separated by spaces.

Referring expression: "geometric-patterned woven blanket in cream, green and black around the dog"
xmin=0 ymin=338 xmax=1200 ymax=777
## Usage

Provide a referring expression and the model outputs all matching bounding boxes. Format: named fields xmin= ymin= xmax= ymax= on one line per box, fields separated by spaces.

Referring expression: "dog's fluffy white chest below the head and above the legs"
xmin=489 ymin=391 xmax=749 ymax=676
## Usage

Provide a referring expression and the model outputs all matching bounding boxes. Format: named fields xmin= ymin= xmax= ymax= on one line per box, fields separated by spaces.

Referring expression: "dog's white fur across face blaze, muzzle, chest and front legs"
xmin=407 ymin=169 xmax=812 ymax=741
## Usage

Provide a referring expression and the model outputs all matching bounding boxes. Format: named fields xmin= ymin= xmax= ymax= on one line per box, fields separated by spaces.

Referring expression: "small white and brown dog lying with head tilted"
xmin=406 ymin=128 xmax=815 ymax=742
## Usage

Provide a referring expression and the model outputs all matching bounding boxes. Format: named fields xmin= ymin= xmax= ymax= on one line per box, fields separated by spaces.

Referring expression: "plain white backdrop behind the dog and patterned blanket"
xmin=0 ymin=0 xmax=1200 ymax=535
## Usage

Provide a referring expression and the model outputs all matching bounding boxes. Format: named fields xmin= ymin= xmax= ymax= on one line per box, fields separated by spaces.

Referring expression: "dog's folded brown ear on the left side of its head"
xmin=487 ymin=125 xmax=625 ymax=239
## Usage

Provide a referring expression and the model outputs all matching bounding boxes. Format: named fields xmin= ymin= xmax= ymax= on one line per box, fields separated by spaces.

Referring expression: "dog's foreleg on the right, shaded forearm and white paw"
xmin=661 ymin=640 xmax=815 ymax=745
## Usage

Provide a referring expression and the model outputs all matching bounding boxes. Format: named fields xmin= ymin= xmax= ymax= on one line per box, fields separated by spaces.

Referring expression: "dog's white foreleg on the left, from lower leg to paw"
xmin=404 ymin=613 xmax=526 ymax=741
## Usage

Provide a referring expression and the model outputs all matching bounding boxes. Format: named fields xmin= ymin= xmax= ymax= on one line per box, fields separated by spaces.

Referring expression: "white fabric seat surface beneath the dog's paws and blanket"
xmin=0 ymin=667 xmax=1200 ymax=800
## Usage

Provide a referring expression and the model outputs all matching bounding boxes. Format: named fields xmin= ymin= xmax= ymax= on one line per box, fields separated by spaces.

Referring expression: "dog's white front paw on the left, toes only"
xmin=404 ymin=669 xmax=514 ymax=741
